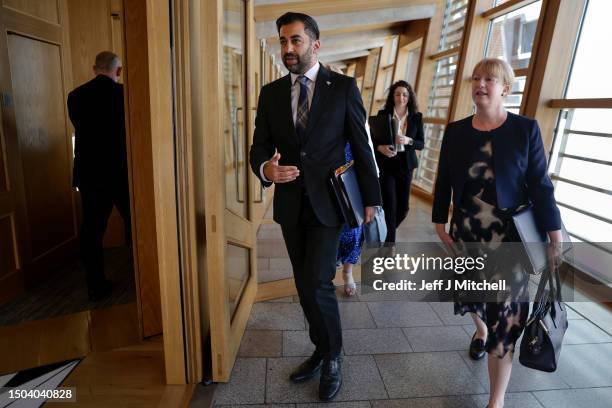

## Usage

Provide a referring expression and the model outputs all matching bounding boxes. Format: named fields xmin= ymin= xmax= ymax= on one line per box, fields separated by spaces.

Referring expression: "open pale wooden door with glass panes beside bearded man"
xmin=201 ymin=0 xmax=257 ymax=382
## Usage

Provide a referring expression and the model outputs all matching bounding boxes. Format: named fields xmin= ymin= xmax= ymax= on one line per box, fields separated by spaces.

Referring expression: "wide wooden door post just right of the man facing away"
xmin=124 ymin=0 xmax=189 ymax=384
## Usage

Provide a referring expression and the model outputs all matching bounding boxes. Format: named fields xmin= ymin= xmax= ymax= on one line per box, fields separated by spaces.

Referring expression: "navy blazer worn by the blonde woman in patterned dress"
xmin=432 ymin=112 xmax=561 ymax=231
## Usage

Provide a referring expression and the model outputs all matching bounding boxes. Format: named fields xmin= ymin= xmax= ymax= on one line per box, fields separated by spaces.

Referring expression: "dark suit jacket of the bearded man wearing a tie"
xmin=250 ymin=65 xmax=381 ymax=226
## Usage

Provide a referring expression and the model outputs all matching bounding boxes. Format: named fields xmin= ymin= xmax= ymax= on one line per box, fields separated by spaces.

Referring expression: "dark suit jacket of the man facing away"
xmin=68 ymin=75 xmax=127 ymax=188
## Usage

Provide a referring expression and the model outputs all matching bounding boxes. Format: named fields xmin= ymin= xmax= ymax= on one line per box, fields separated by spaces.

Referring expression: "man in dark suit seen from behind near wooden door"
xmin=68 ymin=51 xmax=131 ymax=300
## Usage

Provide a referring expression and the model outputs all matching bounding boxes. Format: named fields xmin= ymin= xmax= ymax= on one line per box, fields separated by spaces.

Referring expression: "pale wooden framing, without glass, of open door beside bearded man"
xmin=192 ymin=0 xmax=258 ymax=382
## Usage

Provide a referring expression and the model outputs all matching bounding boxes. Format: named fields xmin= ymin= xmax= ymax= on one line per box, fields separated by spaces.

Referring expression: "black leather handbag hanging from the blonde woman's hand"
xmin=519 ymin=268 xmax=568 ymax=372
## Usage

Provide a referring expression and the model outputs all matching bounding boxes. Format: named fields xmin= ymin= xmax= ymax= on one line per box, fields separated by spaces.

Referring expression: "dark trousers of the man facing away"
xmin=80 ymin=180 xmax=131 ymax=291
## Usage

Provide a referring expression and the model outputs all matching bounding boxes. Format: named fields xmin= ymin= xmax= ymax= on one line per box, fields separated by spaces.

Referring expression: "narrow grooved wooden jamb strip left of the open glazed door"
xmin=171 ymin=0 xmax=203 ymax=383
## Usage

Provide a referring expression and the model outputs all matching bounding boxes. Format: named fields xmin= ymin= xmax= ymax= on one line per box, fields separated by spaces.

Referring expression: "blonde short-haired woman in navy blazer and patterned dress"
xmin=432 ymin=58 xmax=561 ymax=408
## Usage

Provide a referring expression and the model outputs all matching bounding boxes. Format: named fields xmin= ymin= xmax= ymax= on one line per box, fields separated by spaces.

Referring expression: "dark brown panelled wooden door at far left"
xmin=0 ymin=0 xmax=76 ymax=302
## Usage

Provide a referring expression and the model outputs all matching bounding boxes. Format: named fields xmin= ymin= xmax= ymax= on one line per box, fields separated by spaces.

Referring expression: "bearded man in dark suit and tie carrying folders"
xmin=250 ymin=13 xmax=380 ymax=400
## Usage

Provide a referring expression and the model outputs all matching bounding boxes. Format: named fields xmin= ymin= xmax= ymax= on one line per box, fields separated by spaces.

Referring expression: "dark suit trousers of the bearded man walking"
xmin=281 ymin=195 xmax=342 ymax=358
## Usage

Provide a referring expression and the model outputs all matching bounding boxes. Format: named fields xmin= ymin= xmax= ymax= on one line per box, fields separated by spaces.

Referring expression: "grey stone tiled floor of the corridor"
xmin=215 ymin=200 xmax=612 ymax=408
